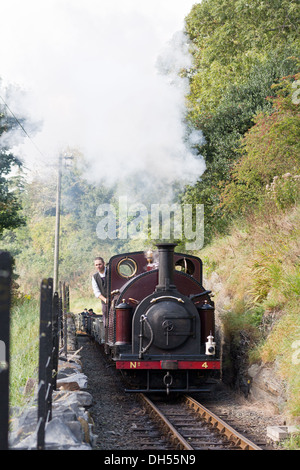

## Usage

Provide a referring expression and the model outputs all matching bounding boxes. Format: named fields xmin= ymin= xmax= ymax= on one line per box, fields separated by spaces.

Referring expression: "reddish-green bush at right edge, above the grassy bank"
xmin=222 ymin=74 xmax=300 ymax=215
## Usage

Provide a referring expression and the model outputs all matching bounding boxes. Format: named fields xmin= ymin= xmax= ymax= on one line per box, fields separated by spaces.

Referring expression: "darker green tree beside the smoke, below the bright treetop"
xmin=182 ymin=56 xmax=295 ymax=242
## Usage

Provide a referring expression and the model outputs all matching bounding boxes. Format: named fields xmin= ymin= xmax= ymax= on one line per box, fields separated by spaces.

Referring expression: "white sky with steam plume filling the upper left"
xmin=0 ymin=0 xmax=205 ymax=200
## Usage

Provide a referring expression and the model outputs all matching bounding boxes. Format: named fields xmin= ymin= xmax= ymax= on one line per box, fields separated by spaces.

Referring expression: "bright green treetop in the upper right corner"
xmin=186 ymin=0 xmax=300 ymax=115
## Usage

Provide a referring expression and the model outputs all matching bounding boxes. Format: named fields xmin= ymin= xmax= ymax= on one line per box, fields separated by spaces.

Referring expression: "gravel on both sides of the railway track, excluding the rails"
xmin=78 ymin=336 xmax=285 ymax=450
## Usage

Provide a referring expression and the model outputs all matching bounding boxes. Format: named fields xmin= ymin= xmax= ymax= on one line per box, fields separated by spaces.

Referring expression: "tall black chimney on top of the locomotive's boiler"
xmin=156 ymin=243 xmax=177 ymax=291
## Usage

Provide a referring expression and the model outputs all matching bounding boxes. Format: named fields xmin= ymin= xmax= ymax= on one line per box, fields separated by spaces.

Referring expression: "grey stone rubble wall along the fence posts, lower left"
xmin=9 ymin=314 xmax=97 ymax=450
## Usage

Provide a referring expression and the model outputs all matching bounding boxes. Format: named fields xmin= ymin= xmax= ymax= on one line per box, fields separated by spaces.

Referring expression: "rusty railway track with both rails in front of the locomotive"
xmin=140 ymin=394 xmax=262 ymax=450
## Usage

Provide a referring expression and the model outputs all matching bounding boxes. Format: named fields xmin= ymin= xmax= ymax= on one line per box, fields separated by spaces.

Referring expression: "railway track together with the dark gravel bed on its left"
xmin=79 ymin=337 xmax=274 ymax=452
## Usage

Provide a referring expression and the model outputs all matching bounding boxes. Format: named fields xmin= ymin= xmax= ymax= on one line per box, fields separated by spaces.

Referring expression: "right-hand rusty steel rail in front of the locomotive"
xmin=184 ymin=395 xmax=262 ymax=450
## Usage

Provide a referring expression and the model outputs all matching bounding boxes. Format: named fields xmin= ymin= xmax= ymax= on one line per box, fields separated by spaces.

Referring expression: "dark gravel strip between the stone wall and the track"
xmin=78 ymin=337 xmax=170 ymax=450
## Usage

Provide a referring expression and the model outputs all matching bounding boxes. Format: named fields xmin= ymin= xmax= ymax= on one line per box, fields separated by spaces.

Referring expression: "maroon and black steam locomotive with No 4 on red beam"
xmin=86 ymin=243 xmax=220 ymax=394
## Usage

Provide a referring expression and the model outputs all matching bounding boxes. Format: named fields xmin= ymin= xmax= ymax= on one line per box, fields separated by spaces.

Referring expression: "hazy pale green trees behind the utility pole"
xmin=1 ymin=151 xmax=123 ymax=300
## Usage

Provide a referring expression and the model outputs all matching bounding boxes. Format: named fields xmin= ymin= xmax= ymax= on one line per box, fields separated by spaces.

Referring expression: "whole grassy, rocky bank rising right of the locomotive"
xmin=200 ymin=206 xmax=300 ymax=422
